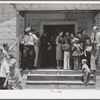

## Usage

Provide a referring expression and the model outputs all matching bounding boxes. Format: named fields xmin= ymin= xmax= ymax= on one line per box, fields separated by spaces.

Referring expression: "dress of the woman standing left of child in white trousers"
xmin=56 ymin=36 xmax=62 ymax=60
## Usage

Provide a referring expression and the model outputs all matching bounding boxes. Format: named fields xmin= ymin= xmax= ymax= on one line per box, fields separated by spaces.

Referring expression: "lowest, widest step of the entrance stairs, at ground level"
xmin=26 ymin=81 xmax=95 ymax=89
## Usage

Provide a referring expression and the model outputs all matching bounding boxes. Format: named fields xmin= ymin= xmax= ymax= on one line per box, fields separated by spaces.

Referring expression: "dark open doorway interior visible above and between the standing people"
xmin=43 ymin=24 xmax=75 ymax=68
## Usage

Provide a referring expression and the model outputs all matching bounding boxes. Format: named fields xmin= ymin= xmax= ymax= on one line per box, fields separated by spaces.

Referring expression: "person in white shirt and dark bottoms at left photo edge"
xmin=0 ymin=49 xmax=9 ymax=89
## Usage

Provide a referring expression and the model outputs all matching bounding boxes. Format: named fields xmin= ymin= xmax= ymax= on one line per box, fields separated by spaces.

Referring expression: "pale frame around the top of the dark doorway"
xmin=40 ymin=21 xmax=78 ymax=36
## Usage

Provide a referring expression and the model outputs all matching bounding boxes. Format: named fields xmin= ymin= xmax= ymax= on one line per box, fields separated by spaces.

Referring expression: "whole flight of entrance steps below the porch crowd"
xmin=26 ymin=69 xmax=95 ymax=89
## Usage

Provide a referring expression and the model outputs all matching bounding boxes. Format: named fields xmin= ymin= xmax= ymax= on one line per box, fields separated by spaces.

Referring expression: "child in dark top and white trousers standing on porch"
xmin=63 ymin=40 xmax=70 ymax=70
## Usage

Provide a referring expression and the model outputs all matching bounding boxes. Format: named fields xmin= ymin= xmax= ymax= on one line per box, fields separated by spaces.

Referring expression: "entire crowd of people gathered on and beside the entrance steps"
xmin=0 ymin=26 xmax=100 ymax=89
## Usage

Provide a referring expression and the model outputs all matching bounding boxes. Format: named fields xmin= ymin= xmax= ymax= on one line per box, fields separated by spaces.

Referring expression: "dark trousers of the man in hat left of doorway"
xmin=22 ymin=45 xmax=35 ymax=69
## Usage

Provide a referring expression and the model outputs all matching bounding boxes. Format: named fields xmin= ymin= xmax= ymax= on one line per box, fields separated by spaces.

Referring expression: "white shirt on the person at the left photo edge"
xmin=0 ymin=60 xmax=9 ymax=77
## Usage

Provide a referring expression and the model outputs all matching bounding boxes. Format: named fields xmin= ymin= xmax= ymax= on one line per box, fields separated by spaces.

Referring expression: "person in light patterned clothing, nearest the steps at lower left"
xmin=8 ymin=54 xmax=22 ymax=89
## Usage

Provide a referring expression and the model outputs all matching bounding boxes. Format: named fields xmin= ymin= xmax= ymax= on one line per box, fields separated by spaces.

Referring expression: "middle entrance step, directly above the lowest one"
xmin=27 ymin=74 xmax=94 ymax=81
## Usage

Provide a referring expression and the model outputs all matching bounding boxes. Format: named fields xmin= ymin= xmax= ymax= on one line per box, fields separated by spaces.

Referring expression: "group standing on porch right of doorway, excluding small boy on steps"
xmin=56 ymin=26 xmax=100 ymax=70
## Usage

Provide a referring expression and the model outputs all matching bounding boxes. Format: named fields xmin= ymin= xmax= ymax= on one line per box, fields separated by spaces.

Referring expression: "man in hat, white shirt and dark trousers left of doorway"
xmin=22 ymin=27 xmax=36 ymax=69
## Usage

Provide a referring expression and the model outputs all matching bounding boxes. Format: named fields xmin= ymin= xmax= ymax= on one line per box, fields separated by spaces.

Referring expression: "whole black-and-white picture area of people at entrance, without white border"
xmin=0 ymin=2 xmax=100 ymax=93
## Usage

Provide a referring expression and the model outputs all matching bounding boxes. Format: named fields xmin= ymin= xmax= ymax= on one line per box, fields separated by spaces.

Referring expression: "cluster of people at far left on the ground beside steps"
xmin=0 ymin=41 xmax=23 ymax=90
